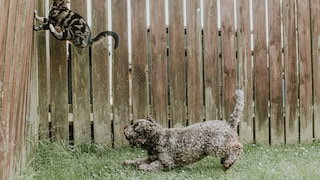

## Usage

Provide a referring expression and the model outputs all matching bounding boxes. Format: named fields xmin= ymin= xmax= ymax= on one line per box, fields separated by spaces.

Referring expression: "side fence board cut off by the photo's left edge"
xmin=0 ymin=1 xmax=10 ymax=179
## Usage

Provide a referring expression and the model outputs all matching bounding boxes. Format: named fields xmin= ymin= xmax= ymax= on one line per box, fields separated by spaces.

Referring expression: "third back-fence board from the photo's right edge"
xmin=282 ymin=0 xmax=299 ymax=144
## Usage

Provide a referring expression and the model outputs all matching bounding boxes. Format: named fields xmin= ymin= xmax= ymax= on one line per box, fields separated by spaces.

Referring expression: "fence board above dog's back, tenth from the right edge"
xmin=169 ymin=0 xmax=186 ymax=127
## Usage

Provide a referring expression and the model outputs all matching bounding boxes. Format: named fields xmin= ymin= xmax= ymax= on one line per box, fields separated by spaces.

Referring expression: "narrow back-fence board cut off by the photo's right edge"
xmin=310 ymin=1 xmax=320 ymax=139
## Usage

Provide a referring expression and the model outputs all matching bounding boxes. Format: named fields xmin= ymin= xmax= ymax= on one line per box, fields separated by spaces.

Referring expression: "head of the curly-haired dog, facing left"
xmin=124 ymin=118 xmax=160 ymax=148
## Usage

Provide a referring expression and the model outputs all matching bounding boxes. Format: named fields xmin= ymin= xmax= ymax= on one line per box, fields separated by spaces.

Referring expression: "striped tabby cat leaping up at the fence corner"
xmin=33 ymin=0 xmax=119 ymax=49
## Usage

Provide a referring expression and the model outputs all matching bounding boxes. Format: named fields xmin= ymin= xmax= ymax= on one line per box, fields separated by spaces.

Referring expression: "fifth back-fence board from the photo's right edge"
xmin=252 ymin=0 xmax=269 ymax=144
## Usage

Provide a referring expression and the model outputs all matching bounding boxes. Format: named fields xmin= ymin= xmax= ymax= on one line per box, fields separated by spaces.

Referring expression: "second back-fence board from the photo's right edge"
xmin=297 ymin=1 xmax=313 ymax=143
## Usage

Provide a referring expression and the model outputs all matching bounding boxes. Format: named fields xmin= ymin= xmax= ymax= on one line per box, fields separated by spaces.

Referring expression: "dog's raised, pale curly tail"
xmin=229 ymin=89 xmax=244 ymax=128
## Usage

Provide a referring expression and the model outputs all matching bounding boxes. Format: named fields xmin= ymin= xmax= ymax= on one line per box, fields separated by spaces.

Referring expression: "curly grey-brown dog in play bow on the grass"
xmin=124 ymin=90 xmax=244 ymax=171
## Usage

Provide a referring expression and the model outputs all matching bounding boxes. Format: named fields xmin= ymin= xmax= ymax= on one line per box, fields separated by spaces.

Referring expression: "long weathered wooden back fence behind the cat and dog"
xmin=36 ymin=0 xmax=320 ymax=147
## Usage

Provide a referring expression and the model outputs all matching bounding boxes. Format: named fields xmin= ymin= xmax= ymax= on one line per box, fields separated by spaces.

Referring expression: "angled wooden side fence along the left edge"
xmin=0 ymin=0 xmax=38 ymax=179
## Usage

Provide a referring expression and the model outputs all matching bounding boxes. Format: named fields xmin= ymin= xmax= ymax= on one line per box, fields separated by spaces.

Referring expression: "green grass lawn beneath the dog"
xmin=15 ymin=142 xmax=320 ymax=180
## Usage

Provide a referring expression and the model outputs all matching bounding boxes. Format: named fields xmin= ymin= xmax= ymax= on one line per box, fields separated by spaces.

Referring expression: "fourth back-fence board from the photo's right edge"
xmin=268 ymin=1 xmax=285 ymax=144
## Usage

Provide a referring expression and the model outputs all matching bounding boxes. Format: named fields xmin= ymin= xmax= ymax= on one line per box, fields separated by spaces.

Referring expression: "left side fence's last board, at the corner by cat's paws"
xmin=16 ymin=0 xmax=34 ymax=167
